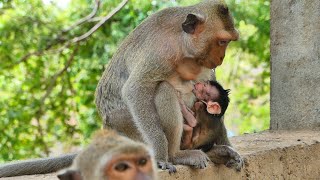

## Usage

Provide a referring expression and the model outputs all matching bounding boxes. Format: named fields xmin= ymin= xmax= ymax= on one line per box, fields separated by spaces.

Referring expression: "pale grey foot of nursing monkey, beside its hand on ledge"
xmin=172 ymin=150 xmax=210 ymax=169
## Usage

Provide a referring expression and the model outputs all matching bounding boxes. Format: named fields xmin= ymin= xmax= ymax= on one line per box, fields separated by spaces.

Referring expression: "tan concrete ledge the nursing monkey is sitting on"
xmin=3 ymin=131 xmax=320 ymax=180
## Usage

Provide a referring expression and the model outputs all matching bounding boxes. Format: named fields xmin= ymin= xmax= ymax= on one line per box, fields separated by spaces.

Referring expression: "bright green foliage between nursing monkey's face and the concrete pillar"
xmin=217 ymin=0 xmax=270 ymax=134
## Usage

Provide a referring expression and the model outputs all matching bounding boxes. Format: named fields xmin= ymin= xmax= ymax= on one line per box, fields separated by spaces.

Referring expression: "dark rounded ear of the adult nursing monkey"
xmin=182 ymin=14 xmax=204 ymax=34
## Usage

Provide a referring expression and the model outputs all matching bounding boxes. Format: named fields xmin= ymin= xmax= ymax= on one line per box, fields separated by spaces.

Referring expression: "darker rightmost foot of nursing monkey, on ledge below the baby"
xmin=207 ymin=145 xmax=244 ymax=171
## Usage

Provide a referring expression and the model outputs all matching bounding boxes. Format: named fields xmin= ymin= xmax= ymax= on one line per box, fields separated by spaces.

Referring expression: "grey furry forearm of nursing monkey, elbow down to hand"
xmin=122 ymin=79 xmax=175 ymax=172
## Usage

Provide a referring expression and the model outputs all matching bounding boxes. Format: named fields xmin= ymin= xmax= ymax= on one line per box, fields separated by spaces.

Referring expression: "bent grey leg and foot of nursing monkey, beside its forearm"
xmin=155 ymin=82 xmax=209 ymax=168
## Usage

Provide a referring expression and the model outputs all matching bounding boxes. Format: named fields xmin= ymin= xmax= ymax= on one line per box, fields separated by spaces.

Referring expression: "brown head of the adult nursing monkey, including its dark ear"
xmin=183 ymin=1 xmax=239 ymax=69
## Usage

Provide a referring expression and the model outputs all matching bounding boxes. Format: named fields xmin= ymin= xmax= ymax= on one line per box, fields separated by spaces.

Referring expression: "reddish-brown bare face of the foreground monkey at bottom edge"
xmin=105 ymin=154 xmax=154 ymax=180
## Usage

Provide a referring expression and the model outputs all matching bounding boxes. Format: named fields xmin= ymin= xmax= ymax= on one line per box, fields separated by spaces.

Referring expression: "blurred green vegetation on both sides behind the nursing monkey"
xmin=0 ymin=0 xmax=270 ymax=162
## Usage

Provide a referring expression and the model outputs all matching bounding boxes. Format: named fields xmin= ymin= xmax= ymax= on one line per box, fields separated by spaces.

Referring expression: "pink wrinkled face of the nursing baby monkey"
xmin=192 ymin=83 xmax=220 ymax=102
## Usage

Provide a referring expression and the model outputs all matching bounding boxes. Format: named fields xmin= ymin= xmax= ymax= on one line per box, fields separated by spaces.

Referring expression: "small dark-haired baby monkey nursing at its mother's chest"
xmin=180 ymin=81 xmax=230 ymax=149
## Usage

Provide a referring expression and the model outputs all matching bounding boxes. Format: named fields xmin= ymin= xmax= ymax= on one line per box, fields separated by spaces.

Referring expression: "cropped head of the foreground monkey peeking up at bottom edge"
xmin=58 ymin=130 xmax=157 ymax=180
